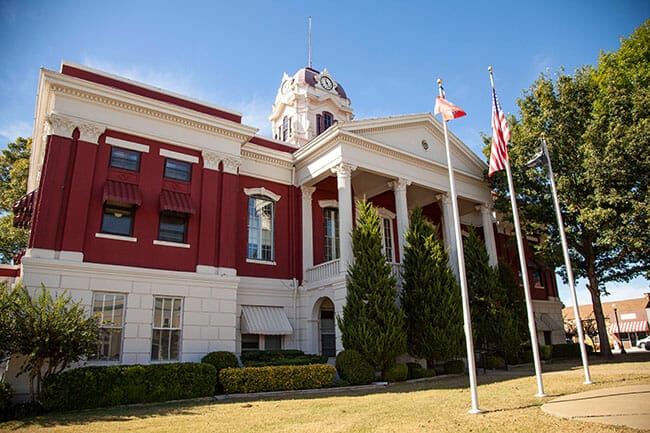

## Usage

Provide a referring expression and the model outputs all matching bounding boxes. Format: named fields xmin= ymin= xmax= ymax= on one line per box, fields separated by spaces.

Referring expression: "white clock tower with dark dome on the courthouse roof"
xmin=269 ymin=67 xmax=354 ymax=147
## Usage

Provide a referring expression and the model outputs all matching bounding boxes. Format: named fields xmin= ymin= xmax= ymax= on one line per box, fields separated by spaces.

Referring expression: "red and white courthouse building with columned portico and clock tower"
xmin=6 ymin=63 xmax=564 ymax=374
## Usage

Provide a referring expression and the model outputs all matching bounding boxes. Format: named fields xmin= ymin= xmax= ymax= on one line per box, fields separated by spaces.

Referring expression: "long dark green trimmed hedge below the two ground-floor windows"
xmin=43 ymin=363 xmax=217 ymax=410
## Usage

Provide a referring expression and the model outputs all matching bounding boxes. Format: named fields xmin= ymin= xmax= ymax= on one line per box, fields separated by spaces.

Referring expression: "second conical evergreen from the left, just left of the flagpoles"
xmin=401 ymin=208 xmax=463 ymax=362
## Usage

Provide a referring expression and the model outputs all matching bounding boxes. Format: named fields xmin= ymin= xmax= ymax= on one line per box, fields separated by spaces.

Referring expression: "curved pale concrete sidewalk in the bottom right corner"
xmin=542 ymin=385 xmax=650 ymax=430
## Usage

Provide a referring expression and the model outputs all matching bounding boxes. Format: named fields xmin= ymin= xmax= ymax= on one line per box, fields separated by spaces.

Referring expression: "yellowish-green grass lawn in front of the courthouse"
xmin=0 ymin=352 xmax=650 ymax=433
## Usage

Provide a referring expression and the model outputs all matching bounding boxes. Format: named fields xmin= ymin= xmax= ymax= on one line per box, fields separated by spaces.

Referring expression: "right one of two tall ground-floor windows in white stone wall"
xmin=151 ymin=297 xmax=182 ymax=361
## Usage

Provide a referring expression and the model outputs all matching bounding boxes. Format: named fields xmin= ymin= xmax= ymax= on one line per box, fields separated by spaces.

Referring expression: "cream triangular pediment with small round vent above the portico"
xmin=340 ymin=113 xmax=487 ymax=177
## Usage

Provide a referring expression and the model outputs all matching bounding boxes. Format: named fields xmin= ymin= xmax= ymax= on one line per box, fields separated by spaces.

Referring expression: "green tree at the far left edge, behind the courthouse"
xmin=0 ymin=137 xmax=32 ymax=263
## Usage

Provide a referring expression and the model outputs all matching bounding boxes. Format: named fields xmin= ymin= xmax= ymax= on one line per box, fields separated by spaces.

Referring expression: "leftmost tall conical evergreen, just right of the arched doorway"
xmin=337 ymin=199 xmax=406 ymax=371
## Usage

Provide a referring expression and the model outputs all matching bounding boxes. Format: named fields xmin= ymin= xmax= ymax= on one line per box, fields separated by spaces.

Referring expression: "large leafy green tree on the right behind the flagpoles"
xmin=491 ymin=20 xmax=650 ymax=355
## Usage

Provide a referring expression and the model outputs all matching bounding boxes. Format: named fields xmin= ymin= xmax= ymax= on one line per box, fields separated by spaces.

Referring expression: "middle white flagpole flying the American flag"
xmin=488 ymin=66 xmax=546 ymax=397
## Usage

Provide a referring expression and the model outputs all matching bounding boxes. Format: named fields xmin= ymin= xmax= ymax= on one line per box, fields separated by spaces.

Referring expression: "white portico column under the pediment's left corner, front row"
xmin=332 ymin=163 xmax=357 ymax=274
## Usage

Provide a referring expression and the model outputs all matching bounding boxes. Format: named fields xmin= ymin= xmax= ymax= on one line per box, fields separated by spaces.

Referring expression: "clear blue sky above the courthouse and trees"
xmin=0 ymin=0 xmax=650 ymax=304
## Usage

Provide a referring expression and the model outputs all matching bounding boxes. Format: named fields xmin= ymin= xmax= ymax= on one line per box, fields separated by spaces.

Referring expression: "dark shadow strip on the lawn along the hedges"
xmin=6 ymin=351 xmax=650 ymax=431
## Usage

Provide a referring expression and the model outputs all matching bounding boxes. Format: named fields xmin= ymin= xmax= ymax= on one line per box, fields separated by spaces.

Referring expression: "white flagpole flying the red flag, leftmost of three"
xmin=438 ymin=79 xmax=483 ymax=414
